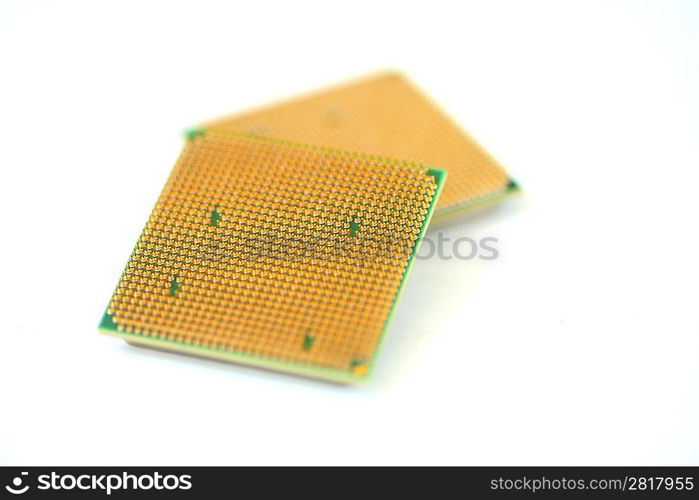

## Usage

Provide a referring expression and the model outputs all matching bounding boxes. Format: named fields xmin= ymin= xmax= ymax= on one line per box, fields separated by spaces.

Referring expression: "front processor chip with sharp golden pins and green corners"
xmin=100 ymin=130 xmax=445 ymax=382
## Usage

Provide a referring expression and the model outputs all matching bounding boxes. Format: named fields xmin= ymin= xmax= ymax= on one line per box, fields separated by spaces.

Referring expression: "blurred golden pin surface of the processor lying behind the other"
xmin=204 ymin=73 xmax=509 ymax=217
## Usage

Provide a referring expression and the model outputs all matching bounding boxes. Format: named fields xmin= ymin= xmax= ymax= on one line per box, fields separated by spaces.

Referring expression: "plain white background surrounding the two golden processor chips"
xmin=0 ymin=0 xmax=699 ymax=465
